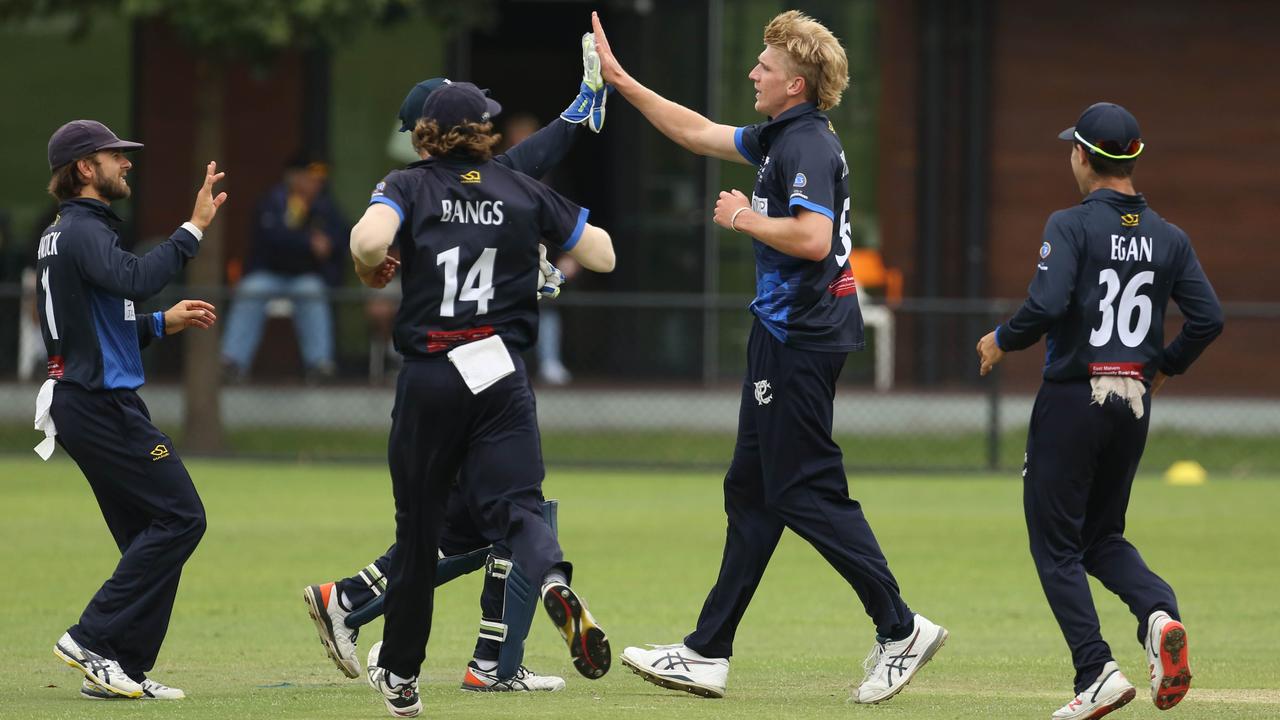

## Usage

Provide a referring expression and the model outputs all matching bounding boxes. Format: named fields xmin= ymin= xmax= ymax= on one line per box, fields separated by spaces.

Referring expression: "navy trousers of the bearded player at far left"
xmin=51 ymin=383 xmax=205 ymax=680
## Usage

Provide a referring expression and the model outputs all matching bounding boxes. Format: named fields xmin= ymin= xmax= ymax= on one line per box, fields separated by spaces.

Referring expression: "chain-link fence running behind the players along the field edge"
xmin=0 ymin=283 xmax=1280 ymax=474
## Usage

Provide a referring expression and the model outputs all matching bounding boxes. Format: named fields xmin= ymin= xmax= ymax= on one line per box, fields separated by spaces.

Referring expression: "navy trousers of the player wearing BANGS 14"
xmin=379 ymin=355 xmax=571 ymax=678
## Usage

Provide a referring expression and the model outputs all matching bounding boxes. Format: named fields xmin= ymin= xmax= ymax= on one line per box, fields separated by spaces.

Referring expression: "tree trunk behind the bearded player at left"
xmin=182 ymin=60 xmax=228 ymax=454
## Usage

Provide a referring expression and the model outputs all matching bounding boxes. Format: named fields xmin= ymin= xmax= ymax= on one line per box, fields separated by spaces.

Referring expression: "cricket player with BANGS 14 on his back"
xmin=351 ymin=82 xmax=614 ymax=717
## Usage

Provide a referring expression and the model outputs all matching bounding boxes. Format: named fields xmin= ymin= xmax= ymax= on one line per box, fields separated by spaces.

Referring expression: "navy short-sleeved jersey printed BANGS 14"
xmin=370 ymin=158 xmax=588 ymax=357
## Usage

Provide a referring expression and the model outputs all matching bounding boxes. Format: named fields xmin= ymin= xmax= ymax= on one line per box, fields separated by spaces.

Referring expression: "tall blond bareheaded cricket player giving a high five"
xmin=591 ymin=10 xmax=947 ymax=703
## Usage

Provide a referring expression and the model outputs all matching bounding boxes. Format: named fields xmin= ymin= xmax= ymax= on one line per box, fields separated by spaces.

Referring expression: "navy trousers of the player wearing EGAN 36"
xmin=1023 ymin=380 xmax=1179 ymax=693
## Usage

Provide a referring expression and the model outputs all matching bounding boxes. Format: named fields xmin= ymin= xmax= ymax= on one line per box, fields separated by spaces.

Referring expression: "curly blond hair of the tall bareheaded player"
xmin=764 ymin=10 xmax=849 ymax=110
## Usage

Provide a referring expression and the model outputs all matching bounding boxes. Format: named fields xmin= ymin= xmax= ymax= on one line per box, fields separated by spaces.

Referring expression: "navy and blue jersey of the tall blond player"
xmin=733 ymin=102 xmax=864 ymax=352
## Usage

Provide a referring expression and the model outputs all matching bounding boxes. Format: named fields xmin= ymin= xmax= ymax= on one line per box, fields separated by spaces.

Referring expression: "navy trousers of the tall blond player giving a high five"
xmin=685 ymin=320 xmax=914 ymax=657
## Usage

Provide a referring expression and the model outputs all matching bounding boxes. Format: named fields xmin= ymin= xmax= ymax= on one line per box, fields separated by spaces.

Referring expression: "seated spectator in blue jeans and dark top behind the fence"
xmin=221 ymin=158 xmax=349 ymax=383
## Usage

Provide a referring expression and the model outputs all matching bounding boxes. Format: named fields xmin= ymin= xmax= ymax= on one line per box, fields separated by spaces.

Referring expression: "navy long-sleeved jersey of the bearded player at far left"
xmin=36 ymin=197 xmax=200 ymax=389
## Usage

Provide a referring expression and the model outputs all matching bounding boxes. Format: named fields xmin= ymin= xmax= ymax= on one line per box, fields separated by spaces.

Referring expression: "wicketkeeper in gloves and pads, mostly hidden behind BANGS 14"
xmin=303 ymin=33 xmax=608 ymax=692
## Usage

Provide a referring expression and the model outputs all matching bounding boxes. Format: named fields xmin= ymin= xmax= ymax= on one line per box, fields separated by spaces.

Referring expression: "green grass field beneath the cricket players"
xmin=0 ymin=451 xmax=1280 ymax=720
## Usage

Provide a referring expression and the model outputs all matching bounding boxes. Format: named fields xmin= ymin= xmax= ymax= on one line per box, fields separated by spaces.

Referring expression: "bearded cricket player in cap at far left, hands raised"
xmin=36 ymin=120 xmax=227 ymax=700
